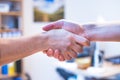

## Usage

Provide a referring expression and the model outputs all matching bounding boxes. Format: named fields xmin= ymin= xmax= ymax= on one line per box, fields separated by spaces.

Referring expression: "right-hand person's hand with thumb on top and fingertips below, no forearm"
xmin=43 ymin=20 xmax=89 ymax=60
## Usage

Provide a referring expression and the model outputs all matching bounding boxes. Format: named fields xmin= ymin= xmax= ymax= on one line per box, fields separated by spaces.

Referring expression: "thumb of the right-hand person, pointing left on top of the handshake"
xmin=43 ymin=21 xmax=63 ymax=31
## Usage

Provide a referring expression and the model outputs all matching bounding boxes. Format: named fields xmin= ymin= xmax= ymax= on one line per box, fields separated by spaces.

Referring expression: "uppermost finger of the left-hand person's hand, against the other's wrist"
xmin=73 ymin=35 xmax=90 ymax=46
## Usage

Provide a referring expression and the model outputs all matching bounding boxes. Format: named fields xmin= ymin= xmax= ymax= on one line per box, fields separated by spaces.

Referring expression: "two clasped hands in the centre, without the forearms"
xmin=43 ymin=20 xmax=94 ymax=61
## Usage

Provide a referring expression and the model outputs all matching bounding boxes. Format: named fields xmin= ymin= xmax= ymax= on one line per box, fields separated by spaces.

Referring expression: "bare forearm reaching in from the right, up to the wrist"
xmin=84 ymin=24 xmax=120 ymax=41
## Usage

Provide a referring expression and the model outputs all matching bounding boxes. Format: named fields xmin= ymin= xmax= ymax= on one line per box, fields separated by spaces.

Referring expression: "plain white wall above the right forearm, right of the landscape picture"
xmin=65 ymin=0 xmax=120 ymax=23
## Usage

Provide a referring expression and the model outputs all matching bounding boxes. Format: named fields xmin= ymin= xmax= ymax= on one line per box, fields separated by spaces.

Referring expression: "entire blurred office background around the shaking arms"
xmin=0 ymin=0 xmax=120 ymax=80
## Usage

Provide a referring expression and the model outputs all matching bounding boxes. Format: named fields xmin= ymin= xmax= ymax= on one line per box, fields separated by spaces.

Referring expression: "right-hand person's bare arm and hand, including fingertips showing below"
xmin=43 ymin=20 xmax=120 ymax=61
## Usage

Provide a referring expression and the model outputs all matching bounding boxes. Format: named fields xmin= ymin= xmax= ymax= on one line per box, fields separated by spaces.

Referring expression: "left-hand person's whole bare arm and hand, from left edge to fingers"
xmin=0 ymin=29 xmax=89 ymax=65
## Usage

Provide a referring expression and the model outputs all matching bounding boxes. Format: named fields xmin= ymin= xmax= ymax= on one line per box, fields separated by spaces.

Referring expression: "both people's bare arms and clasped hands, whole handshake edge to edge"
xmin=0 ymin=20 xmax=120 ymax=65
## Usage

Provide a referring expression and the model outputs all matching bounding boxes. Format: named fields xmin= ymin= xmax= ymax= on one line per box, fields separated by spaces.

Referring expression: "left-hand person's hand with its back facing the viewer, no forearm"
xmin=45 ymin=29 xmax=89 ymax=60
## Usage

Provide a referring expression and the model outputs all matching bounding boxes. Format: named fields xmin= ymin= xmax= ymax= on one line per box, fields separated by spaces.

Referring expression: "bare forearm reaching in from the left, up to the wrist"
xmin=0 ymin=34 xmax=47 ymax=65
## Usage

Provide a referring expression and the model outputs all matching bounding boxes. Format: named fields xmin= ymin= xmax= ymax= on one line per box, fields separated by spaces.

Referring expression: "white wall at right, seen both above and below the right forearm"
xmin=65 ymin=0 xmax=120 ymax=57
